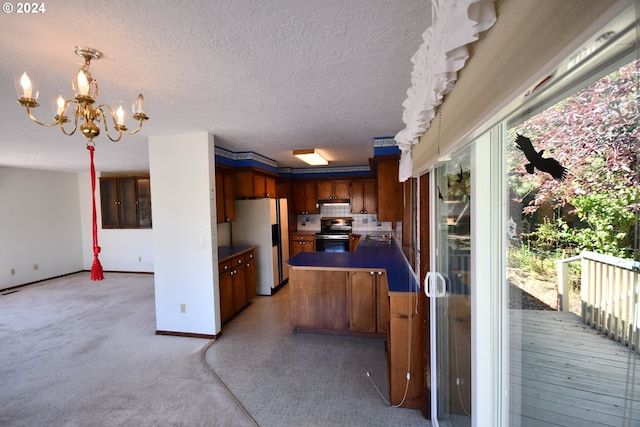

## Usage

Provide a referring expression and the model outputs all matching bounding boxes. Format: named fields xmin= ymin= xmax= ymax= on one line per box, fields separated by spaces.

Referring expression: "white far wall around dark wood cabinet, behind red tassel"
xmin=78 ymin=172 xmax=155 ymax=272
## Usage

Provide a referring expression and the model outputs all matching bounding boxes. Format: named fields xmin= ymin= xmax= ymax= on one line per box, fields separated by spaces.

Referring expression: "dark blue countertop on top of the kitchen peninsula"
xmin=286 ymin=239 xmax=418 ymax=292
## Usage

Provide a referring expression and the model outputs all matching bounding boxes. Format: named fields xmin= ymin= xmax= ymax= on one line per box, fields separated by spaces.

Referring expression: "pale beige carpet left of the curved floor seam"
xmin=0 ymin=273 xmax=253 ymax=427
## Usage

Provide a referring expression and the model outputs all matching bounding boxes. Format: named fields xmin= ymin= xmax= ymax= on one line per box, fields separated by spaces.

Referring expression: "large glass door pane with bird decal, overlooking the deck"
xmin=504 ymin=56 xmax=640 ymax=426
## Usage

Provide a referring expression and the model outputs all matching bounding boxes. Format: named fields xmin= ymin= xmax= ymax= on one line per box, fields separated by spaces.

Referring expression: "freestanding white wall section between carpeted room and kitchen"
xmin=149 ymin=132 xmax=221 ymax=335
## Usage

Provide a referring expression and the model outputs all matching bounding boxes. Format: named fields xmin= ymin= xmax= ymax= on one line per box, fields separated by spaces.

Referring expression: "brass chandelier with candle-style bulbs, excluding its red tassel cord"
xmin=16 ymin=46 xmax=149 ymax=143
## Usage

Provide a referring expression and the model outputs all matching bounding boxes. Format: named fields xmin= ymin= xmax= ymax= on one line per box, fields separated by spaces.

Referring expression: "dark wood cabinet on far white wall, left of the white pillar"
xmin=100 ymin=177 xmax=151 ymax=228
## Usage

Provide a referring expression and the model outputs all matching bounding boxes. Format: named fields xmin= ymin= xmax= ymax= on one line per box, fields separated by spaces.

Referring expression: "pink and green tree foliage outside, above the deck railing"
xmin=507 ymin=61 xmax=640 ymax=257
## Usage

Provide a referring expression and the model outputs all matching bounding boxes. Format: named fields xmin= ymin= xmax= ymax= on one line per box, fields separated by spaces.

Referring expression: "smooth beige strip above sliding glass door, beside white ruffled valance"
xmin=413 ymin=0 xmax=630 ymax=176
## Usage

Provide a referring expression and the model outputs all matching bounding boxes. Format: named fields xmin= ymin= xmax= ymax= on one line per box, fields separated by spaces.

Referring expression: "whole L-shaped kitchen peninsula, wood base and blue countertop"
xmin=287 ymin=236 xmax=424 ymax=408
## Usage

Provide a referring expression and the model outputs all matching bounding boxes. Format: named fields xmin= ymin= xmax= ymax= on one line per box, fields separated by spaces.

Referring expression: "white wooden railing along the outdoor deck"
xmin=557 ymin=252 xmax=640 ymax=352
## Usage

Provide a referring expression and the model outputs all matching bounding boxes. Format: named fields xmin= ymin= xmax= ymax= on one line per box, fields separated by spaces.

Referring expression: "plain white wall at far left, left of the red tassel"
xmin=0 ymin=167 xmax=83 ymax=289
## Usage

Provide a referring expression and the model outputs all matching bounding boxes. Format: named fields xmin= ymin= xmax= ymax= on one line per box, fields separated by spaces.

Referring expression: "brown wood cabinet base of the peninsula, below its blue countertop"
xmin=289 ymin=267 xmax=424 ymax=408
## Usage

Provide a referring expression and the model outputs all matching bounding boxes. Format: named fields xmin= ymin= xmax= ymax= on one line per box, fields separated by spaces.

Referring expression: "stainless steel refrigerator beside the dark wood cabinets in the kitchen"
xmin=231 ymin=199 xmax=289 ymax=295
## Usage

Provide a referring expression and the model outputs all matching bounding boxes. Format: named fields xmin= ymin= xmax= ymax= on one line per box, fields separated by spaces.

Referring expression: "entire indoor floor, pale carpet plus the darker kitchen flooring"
xmin=0 ymin=273 xmax=429 ymax=426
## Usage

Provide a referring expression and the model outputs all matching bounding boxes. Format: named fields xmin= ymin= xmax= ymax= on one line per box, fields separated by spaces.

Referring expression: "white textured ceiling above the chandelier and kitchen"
xmin=0 ymin=0 xmax=431 ymax=172
